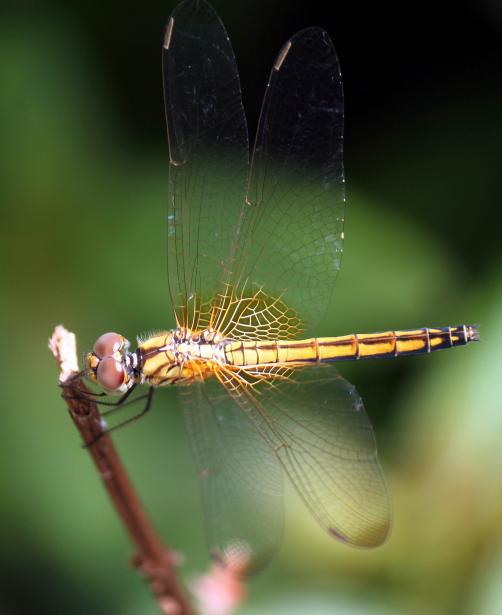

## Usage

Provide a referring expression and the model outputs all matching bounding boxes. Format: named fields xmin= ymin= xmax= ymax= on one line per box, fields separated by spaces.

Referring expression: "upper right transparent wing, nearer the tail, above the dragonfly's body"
xmin=213 ymin=28 xmax=345 ymax=330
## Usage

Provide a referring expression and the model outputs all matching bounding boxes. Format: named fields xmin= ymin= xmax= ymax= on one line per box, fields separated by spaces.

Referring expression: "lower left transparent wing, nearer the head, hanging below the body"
xmin=179 ymin=379 xmax=283 ymax=572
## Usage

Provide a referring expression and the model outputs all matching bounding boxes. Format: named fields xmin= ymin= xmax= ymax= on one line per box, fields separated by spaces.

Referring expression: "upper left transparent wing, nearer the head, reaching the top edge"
xmin=162 ymin=0 xmax=249 ymax=328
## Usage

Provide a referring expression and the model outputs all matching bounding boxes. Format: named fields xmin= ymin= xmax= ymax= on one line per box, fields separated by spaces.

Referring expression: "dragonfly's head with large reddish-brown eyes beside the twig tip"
xmin=85 ymin=332 xmax=136 ymax=394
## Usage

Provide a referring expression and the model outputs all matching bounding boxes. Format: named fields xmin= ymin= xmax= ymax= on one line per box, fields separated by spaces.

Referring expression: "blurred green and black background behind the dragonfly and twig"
xmin=0 ymin=0 xmax=502 ymax=615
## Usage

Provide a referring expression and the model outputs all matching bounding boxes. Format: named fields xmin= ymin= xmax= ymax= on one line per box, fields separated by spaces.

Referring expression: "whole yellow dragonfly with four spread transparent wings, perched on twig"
xmin=86 ymin=0 xmax=478 ymax=571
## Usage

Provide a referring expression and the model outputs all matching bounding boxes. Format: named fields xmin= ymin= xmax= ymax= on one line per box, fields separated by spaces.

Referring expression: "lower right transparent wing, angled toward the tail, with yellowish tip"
xmin=220 ymin=366 xmax=389 ymax=547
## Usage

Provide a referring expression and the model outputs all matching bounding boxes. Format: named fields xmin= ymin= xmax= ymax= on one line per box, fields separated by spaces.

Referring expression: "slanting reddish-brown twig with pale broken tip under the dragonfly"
xmin=49 ymin=326 xmax=191 ymax=615
